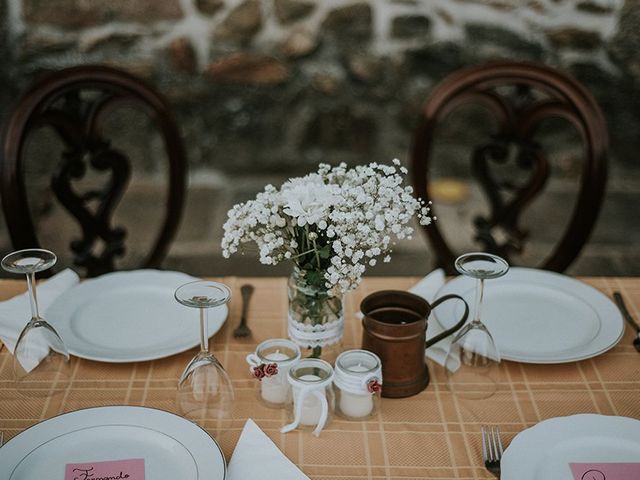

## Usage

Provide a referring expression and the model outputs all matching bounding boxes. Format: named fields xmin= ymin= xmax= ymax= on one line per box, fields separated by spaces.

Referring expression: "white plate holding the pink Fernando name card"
xmin=0 ymin=406 xmax=227 ymax=480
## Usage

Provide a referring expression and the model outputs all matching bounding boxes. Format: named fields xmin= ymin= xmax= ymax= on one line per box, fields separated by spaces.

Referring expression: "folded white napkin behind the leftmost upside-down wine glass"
xmin=0 ymin=269 xmax=79 ymax=371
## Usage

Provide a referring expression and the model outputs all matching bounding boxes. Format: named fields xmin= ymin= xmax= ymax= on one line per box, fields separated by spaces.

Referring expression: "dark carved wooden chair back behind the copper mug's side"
xmin=411 ymin=62 xmax=608 ymax=272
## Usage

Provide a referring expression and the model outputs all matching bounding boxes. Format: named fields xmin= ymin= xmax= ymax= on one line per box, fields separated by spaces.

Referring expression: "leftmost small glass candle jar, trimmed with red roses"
xmin=247 ymin=338 xmax=300 ymax=408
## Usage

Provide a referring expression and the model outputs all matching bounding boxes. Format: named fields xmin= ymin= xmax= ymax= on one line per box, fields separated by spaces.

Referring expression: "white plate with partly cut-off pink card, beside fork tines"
xmin=500 ymin=414 xmax=640 ymax=480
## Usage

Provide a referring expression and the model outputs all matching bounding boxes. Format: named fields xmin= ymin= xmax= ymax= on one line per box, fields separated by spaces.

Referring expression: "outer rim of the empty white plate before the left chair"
xmin=44 ymin=268 xmax=229 ymax=363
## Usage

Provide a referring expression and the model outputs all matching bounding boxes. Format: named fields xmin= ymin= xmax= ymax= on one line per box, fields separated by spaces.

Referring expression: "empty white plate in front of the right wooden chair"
xmin=434 ymin=267 xmax=624 ymax=363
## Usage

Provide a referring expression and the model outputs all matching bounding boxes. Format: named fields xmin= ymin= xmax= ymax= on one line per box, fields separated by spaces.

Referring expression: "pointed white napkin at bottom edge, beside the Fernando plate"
xmin=227 ymin=419 xmax=309 ymax=480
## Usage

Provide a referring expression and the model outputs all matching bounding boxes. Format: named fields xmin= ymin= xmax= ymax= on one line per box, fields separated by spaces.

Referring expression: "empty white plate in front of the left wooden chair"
xmin=45 ymin=270 xmax=228 ymax=363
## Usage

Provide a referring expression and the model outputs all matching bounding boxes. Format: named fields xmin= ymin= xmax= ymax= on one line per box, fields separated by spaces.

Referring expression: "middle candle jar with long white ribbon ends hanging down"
xmin=281 ymin=358 xmax=335 ymax=436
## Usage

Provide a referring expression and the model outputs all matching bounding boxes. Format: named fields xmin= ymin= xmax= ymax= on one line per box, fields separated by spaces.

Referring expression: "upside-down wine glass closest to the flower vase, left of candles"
xmin=175 ymin=281 xmax=234 ymax=433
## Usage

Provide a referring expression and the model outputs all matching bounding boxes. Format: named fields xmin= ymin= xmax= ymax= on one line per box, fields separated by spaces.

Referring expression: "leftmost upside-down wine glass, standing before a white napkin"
xmin=1 ymin=248 xmax=70 ymax=397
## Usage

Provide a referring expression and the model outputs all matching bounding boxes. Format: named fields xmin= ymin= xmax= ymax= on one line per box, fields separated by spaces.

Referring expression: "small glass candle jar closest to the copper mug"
xmin=333 ymin=350 xmax=382 ymax=420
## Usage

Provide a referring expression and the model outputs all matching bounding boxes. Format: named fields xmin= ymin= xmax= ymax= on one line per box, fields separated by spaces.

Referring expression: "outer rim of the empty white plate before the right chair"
xmin=434 ymin=267 xmax=625 ymax=365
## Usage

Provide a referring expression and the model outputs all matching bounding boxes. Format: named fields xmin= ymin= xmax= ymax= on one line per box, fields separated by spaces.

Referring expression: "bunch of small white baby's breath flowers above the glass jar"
xmin=222 ymin=159 xmax=435 ymax=293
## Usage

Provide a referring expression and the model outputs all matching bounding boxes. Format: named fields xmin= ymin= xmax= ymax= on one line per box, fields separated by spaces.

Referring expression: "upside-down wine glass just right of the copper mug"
xmin=445 ymin=252 xmax=509 ymax=400
